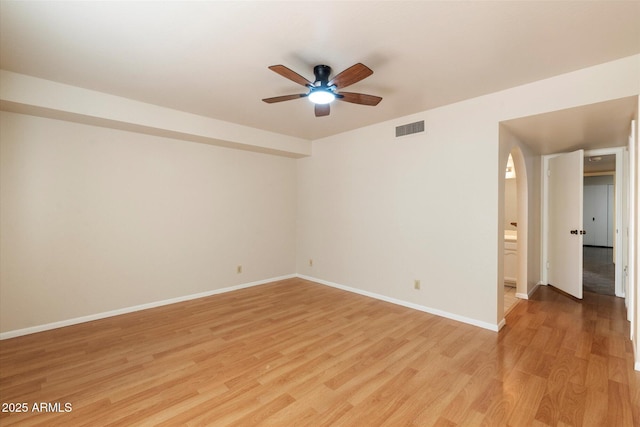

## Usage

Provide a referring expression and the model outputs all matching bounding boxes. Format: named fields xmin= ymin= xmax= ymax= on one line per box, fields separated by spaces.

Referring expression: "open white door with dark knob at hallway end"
xmin=547 ymin=150 xmax=584 ymax=299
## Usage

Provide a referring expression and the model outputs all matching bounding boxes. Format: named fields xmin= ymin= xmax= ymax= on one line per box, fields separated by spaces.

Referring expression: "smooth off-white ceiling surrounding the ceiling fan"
xmin=0 ymin=0 xmax=640 ymax=152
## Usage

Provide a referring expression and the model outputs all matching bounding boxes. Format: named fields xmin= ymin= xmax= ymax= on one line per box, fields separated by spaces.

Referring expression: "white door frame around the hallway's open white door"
xmin=540 ymin=147 xmax=628 ymax=298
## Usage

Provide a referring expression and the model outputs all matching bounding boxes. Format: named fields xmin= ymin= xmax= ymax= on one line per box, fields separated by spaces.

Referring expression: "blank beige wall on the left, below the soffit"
xmin=0 ymin=112 xmax=296 ymax=332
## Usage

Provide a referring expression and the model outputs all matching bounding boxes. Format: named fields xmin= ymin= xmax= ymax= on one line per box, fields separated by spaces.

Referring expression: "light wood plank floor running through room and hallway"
xmin=0 ymin=279 xmax=640 ymax=427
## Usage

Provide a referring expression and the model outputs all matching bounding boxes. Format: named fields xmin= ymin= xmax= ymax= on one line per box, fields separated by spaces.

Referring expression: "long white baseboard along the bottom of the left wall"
xmin=0 ymin=274 xmax=296 ymax=341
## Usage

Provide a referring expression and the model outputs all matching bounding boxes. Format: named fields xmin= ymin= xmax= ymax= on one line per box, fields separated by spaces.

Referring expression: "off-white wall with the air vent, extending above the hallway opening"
xmin=297 ymin=56 xmax=640 ymax=326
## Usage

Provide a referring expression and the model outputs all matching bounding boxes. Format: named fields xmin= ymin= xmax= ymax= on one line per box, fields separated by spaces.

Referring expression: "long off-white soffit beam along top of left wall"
xmin=0 ymin=70 xmax=311 ymax=158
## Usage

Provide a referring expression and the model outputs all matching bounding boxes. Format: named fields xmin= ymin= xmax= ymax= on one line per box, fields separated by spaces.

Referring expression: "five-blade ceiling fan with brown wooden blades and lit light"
xmin=263 ymin=63 xmax=382 ymax=117
